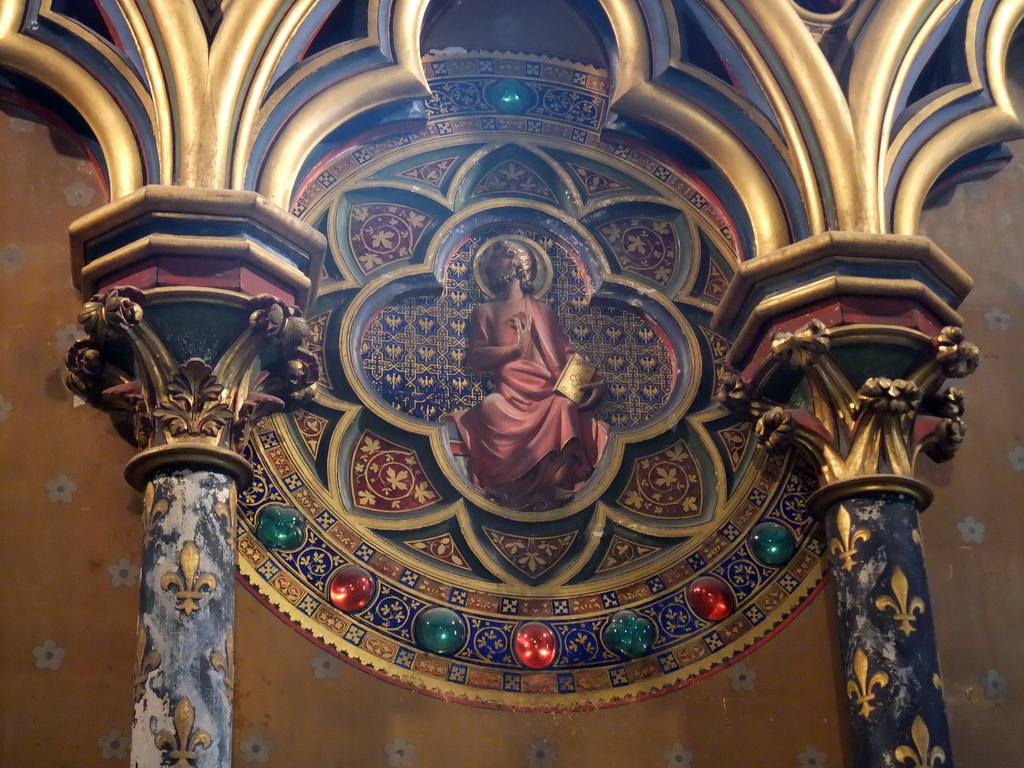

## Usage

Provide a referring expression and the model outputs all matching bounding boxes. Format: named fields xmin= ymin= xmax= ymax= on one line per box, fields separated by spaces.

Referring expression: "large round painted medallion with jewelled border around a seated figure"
xmin=239 ymin=54 xmax=822 ymax=709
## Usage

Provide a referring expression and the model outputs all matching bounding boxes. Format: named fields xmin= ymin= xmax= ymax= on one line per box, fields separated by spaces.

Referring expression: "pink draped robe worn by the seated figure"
xmin=453 ymin=296 xmax=607 ymax=509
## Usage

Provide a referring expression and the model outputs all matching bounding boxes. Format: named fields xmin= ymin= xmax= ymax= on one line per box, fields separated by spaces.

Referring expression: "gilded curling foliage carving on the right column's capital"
xmin=733 ymin=319 xmax=979 ymax=483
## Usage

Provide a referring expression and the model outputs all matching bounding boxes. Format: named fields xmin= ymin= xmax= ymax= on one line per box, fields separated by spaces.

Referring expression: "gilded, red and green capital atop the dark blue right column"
xmin=715 ymin=232 xmax=979 ymax=512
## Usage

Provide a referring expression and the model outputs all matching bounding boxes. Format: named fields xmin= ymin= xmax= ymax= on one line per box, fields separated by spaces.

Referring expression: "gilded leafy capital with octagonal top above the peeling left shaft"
xmin=66 ymin=187 xmax=325 ymax=487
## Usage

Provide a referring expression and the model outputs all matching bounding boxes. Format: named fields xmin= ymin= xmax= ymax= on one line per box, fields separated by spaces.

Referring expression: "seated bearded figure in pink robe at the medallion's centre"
xmin=452 ymin=237 xmax=608 ymax=510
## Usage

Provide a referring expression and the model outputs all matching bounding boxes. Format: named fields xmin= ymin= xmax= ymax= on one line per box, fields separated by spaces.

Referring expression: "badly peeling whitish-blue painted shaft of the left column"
xmin=132 ymin=469 xmax=236 ymax=768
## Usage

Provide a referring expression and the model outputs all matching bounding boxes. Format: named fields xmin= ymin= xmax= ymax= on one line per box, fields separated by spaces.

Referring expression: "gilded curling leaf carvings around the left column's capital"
xmin=65 ymin=287 xmax=321 ymax=462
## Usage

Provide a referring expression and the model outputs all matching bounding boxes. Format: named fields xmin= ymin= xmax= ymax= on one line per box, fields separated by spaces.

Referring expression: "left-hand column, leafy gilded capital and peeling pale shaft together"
xmin=67 ymin=187 xmax=325 ymax=768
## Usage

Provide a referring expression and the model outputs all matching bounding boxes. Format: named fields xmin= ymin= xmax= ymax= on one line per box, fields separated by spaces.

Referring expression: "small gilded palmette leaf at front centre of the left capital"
xmin=153 ymin=357 xmax=234 ymax=437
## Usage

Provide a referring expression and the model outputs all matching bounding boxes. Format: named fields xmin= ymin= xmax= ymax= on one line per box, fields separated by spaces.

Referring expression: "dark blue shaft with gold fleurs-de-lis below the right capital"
xmin=825 ymin=490 xmax=953 ymax=768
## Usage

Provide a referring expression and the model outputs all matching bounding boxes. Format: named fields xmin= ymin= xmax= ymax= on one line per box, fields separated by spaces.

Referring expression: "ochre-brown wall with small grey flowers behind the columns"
xmin=0 ymin=60 xmax=1024 ymax=768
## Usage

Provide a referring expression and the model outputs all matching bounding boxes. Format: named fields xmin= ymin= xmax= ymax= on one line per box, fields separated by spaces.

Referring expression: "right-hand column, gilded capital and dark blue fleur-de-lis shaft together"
xmin=716 ymin=232 xmax=978 ymax=768
